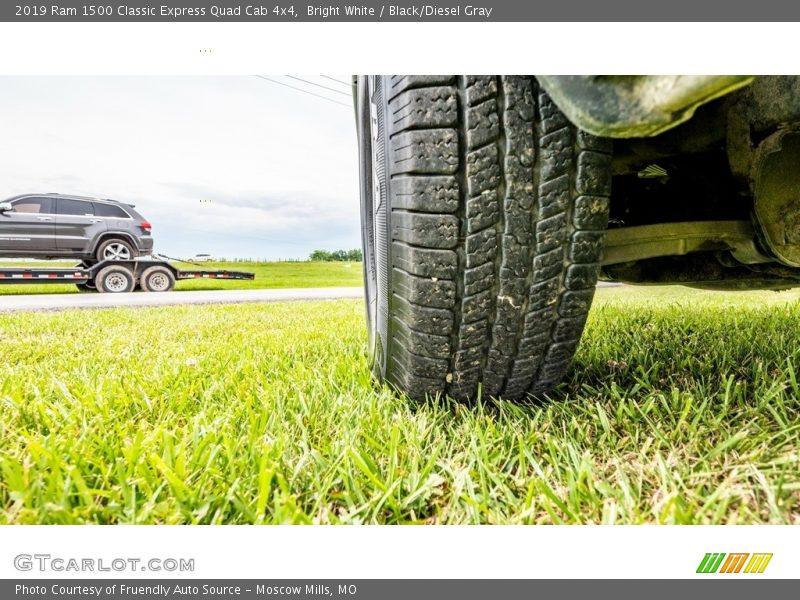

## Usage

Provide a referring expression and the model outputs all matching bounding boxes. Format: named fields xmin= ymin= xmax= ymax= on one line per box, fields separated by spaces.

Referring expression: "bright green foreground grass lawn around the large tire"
xmin=0 ymin=287 xmax=800 ymax=524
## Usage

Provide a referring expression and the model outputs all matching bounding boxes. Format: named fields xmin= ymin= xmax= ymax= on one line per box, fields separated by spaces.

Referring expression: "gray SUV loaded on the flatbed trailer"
xmin=0 ymin=194 xmax=153 ymax=260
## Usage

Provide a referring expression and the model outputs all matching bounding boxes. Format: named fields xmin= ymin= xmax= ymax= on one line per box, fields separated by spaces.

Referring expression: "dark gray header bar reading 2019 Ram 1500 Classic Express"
xmin=0 ymin=0 xmax=800 ymax=21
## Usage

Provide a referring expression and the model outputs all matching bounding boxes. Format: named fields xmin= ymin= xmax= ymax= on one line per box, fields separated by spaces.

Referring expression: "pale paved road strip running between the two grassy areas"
xmin=0 ymin=288 xmax=364 ymax=312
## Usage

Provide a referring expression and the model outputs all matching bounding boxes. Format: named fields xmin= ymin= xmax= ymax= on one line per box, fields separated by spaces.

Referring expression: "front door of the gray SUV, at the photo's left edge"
xmin=0 ymin=196 xmax=55 ymax=256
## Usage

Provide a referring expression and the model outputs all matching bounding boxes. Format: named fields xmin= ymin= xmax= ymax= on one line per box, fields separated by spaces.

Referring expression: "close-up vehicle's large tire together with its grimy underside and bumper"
xmin=354 ymin=75 xmax=800 ymax=400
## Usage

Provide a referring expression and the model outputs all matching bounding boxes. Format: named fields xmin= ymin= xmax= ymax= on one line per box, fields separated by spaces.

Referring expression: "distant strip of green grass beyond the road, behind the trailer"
xmin=0 ymin=261 xmax=362 ymax=296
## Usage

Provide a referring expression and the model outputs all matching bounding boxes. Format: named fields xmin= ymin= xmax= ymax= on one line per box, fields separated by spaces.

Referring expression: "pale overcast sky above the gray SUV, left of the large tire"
xmin=0 ymin=75 xmax=360 ymax=259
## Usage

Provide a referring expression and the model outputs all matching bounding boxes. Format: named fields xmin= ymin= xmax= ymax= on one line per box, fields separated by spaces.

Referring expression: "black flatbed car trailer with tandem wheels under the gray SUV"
xmin=0 ymin=258 xmax=255 ymax=294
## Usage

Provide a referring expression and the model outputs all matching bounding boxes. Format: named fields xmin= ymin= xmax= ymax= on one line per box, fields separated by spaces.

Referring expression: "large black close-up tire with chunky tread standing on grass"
xmin=356 ymin=75 xmax=611 ymax=400
